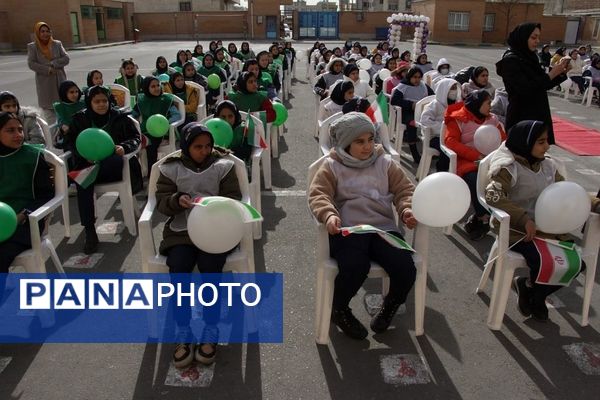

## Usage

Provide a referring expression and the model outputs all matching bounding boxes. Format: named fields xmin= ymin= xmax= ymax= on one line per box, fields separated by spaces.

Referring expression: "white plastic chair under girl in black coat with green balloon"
xmin=94 ymin=117 xmax=142 ymax=236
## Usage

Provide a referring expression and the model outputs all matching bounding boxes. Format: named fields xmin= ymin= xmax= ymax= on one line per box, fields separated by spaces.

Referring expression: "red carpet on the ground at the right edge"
xmin=552 ymin=117 xmax=600 ymax=156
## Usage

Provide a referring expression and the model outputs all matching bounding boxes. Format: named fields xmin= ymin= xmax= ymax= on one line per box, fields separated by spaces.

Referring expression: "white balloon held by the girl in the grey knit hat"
xmin=412 ymin=172 xmax=471 ymax=228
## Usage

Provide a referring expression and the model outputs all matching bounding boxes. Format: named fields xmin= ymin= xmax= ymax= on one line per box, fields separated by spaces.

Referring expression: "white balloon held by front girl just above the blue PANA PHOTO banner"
xmin=187 ymin=196 xmax=244 ymax=254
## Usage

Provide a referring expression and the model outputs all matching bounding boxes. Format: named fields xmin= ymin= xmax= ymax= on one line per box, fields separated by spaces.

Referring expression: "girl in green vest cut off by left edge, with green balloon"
xmin=0 ymin=112 xmax=54 ymax=304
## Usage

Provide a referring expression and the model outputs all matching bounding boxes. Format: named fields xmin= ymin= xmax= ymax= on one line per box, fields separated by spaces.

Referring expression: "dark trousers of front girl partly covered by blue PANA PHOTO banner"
xmin=167 ymin=245 xmax=233 ymax=328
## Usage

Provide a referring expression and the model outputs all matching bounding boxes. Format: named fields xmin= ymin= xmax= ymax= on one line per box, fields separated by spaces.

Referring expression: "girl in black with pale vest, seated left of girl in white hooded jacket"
xmin=390 ymin=67 xmax=435 ymax=164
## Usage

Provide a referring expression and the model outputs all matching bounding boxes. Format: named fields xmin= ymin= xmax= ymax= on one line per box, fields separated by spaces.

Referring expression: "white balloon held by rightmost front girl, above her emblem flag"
xmin=535 ymin=181 xmax=591 ymax=234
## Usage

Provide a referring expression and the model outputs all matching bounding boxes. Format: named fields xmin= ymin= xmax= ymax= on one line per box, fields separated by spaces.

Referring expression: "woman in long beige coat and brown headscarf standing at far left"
xmin=27 ymin=22 xmax=69 ymax=113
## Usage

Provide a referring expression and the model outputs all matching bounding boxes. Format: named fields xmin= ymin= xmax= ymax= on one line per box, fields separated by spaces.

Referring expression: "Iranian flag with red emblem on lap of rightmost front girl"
xmin=533 ymin=238 xmax=581 ymax=286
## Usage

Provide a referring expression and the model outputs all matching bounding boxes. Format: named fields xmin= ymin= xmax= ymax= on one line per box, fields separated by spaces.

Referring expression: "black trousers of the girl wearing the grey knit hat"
xmin=329 ymin=232 xmax=417 ymax=309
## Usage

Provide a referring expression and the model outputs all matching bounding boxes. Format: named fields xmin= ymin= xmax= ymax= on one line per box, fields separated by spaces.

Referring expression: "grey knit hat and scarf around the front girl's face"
xmin=329 ymin=111 xmax=377 ymax=168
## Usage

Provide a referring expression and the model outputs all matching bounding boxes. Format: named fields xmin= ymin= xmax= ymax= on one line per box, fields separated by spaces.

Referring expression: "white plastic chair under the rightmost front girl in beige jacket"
xmin=476 ymin=152 xmax=600 ymax=330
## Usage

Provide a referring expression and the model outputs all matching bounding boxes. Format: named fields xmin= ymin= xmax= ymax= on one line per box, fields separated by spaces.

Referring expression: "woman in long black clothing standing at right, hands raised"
xmin=496 ymin=22 xmax=569 ymax=144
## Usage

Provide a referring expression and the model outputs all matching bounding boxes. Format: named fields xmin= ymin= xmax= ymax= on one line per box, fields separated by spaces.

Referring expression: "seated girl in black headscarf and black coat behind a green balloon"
xmin=65 ymin=86 xmax=142 ymax=254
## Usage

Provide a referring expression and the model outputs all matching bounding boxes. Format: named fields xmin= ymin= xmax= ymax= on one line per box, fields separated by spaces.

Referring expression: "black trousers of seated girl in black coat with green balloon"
xmin=77 ymin=154 xmax=123 ymax=227
